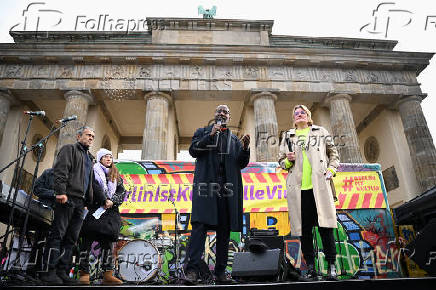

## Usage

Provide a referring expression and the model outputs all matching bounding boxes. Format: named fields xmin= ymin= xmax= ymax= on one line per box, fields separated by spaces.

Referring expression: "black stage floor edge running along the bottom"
xmin=2 ymin=277 xmax=436 ymax=290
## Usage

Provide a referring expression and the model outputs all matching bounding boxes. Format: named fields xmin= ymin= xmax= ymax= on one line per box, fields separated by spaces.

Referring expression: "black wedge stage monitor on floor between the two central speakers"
xmin=232 ymin=249 xmax=285 ymax=281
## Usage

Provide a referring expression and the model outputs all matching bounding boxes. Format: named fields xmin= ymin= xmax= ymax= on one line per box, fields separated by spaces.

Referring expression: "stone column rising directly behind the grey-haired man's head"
xmin=55 ymin=90 xmax=93 ymax=156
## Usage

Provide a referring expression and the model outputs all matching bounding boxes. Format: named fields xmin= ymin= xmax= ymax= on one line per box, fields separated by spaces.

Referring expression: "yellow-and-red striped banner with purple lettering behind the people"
xmin=120 ymin=171 xmax=386 ymax=213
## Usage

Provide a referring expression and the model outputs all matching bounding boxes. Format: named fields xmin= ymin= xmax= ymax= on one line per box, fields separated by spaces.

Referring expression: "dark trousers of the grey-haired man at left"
xmin=44 ymin=196 xmax=84 ymax=271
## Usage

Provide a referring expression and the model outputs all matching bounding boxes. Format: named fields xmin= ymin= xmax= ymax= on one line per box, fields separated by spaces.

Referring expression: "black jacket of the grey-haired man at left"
xmin=53 ymin=142 xmax=94 ymax=205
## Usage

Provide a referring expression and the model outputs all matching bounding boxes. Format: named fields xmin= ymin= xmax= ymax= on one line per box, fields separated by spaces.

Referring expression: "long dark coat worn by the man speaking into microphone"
xmin=189 ymin=125 xmax=250 ymax=232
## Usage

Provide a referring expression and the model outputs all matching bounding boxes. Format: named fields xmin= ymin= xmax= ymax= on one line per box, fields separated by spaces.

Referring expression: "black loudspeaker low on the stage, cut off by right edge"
xmin=406 ymin=219 xmax=436 ymax=276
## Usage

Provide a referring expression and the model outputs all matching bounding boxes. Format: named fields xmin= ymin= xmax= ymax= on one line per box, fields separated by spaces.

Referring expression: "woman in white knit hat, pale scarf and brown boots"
xmin=79 ymin=148 xmax=126 ymax=285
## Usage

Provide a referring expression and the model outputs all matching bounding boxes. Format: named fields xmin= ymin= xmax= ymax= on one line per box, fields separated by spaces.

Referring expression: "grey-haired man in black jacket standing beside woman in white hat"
xmin=41 ymin=126 xmax=95 ymax=285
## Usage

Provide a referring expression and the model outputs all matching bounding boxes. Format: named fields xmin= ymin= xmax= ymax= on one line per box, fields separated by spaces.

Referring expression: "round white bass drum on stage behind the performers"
xmin=117 ymin=240 xmax=161 ymax=282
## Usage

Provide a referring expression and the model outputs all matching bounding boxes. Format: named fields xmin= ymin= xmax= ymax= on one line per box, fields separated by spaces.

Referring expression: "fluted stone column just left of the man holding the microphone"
xmin=141 ymin=92 xmax=171 ymax=160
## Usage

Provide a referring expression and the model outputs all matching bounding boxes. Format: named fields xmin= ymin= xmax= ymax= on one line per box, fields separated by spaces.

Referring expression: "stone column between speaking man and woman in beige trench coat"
xmin=250 ymin=92 xmax=279 ymax=162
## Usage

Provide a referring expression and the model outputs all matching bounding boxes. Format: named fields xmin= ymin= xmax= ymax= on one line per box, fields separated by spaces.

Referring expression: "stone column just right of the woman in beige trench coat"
xmin=326 ymin=94 xmax=363 ymax=163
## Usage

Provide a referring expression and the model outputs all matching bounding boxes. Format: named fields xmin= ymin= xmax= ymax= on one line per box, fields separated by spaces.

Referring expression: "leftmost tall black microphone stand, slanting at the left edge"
xmin=0 ymin=115 xmax=33 ymax=276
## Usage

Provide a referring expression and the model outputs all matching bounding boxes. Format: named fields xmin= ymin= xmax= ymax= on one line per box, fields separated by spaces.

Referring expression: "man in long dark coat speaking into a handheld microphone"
xmin=186 ymin=105 xmax=250 ymax=284
